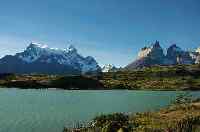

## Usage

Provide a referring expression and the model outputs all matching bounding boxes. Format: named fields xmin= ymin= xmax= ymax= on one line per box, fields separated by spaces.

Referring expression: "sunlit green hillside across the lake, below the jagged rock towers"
xmin=101 ymin=65 xmax=200 ymax=90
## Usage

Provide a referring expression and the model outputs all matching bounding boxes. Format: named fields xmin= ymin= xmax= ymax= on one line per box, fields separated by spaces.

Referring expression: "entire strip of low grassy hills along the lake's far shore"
xmin=0 ymin=65 xmax=200 ymax=90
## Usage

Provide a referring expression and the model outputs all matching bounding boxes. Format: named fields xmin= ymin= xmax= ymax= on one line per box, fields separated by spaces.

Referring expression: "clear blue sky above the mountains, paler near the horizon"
xmin=0 ymin=0 xmax=200 ymax=67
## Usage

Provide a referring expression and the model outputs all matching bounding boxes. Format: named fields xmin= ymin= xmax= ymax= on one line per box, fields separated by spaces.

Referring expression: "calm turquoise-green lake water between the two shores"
xmin=0 ymin=89 xmax=200 ymax=132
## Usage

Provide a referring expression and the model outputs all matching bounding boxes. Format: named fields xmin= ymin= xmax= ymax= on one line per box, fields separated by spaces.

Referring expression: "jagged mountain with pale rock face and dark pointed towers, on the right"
xmin=125 ymin=41 xmax=200 ymax=69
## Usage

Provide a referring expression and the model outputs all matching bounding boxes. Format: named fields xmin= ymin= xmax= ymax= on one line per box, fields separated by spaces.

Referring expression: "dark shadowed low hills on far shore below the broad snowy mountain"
xmin=0 ymin=75 xmax=103 ymax=89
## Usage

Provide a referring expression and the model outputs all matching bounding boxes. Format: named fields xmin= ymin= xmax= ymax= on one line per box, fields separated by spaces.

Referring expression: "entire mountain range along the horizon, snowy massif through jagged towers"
xmin=0 ymin=41 xmax=200 ymax=75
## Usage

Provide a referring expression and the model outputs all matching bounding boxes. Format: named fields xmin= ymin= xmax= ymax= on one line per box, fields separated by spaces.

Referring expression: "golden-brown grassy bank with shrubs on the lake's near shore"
xmin=64 ymin=97 xmax=200 ymax=132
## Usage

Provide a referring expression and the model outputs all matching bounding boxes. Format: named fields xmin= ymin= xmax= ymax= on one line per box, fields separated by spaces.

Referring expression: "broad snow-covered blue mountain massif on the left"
xmin=0 ymin=43 xmax=101 ymax=74
